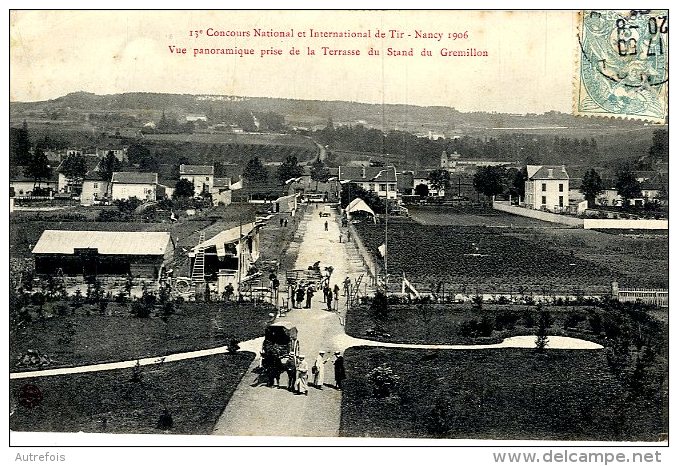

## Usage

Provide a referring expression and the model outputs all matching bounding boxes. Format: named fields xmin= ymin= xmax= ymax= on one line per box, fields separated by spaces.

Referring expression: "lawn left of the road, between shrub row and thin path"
xmin=10 ymin=302 xmax=271 ymax=371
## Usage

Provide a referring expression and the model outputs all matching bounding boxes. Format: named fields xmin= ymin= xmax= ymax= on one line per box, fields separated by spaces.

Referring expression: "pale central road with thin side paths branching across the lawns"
xmin=10 ymin=208 xmax=602 ymax=437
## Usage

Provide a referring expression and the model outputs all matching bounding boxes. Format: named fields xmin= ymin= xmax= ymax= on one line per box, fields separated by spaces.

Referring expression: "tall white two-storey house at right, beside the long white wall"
xmin=525 ymin=165 xmax=570 ymax=212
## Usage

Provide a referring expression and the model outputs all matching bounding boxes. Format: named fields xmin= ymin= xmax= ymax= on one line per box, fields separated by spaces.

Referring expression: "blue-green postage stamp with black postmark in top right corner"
xmin=573 ymin=10 xmax=669 ymax=123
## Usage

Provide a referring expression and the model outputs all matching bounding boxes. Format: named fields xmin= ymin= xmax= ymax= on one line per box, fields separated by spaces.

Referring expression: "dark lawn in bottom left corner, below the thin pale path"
xmin=9 ymin=353 xmax=254 ymax=435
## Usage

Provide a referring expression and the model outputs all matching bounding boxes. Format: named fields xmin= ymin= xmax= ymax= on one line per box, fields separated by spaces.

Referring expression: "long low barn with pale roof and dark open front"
xmin=33 ymin=230 xmax=174 ymax=279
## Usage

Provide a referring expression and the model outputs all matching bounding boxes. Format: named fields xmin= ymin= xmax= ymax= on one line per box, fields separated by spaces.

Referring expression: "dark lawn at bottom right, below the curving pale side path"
xmin=340 ymin=347 xmax=668 ymax=441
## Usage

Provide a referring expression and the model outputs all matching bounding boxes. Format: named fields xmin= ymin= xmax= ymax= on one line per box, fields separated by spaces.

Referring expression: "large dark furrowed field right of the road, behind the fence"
xmin=356 ymin=222 xmax=618 ymax=294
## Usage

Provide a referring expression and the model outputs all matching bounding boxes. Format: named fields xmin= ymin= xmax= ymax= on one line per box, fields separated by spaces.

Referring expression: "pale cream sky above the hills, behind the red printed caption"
xmin=10 ymin=11 xmax=577 ymax=113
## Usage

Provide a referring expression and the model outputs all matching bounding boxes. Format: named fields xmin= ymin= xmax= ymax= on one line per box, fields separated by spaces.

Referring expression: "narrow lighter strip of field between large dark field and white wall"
xmin=408 ymin=206 xmax=563 ymax=228
